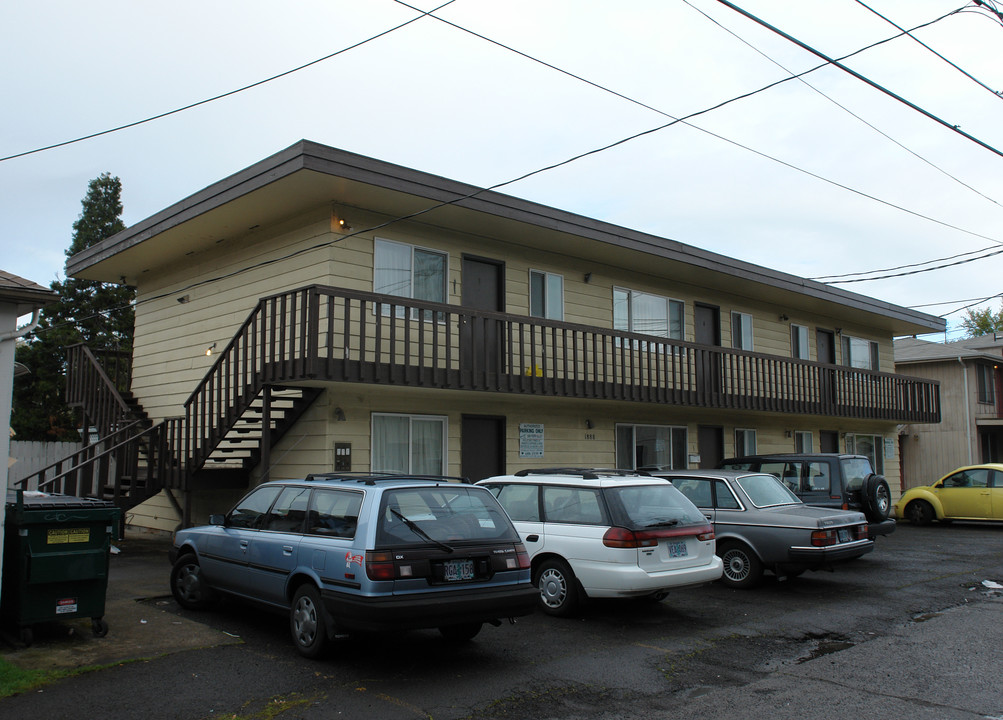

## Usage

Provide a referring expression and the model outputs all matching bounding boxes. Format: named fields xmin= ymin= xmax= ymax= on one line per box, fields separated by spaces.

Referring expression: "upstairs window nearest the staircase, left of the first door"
xmin=373 ymin=238 xmax=447 ymax=303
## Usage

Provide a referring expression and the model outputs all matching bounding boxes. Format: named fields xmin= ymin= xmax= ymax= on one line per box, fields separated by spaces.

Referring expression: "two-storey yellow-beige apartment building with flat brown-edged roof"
xmin=47 ymin=141 xmax=944 ymax=529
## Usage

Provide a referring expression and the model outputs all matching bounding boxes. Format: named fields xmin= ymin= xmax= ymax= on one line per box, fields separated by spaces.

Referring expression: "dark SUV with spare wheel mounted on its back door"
xmin=718 ymin=452 xmax=895 ymax=539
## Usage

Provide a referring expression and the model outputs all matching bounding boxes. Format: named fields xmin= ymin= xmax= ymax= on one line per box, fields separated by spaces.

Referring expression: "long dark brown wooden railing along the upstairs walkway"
xmin=186 ymin=286 xmax=940 ymax=466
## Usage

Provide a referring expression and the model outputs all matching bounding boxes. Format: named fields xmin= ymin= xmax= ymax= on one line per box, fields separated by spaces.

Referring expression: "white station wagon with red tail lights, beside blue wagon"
xmin=477 ymin=468 xmax=722 ymax=616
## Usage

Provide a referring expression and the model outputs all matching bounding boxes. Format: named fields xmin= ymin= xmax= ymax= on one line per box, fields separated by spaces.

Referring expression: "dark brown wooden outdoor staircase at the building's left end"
xmin=17 ymin=296 xmax=323 ymax=524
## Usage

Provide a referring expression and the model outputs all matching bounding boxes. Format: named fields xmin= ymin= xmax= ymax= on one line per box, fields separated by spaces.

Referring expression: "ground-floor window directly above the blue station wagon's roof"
xmin=371 ymin=413 xmax=447 ymax=475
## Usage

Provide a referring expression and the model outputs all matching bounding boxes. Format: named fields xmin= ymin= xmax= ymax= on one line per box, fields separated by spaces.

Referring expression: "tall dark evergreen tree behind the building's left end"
xmin=11 ymin=172 xmax=135 ymax=440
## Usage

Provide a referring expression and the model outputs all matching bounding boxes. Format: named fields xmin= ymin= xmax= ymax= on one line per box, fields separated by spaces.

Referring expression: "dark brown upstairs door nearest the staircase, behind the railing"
xmin=460 ymin=257 xmax=505 ymax=385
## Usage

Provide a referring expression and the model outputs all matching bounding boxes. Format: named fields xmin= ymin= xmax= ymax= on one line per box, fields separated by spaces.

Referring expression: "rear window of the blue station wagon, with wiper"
xmin=376 ymin=485 xmax=519 ymax=548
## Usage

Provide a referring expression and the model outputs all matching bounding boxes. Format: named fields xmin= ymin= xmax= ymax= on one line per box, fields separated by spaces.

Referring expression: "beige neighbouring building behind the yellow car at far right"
xmin=895 ymin=335 xmax=1003 ymax=490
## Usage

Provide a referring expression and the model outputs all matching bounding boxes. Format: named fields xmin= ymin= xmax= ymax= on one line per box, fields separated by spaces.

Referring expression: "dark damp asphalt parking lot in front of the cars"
xmin=0 ymin=523 xmax=1003 ymax=720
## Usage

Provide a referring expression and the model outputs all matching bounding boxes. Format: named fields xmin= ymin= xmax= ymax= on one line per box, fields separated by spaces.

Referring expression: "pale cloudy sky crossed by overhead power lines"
xmin=0 ymin=0 xmax=1003 ymax=339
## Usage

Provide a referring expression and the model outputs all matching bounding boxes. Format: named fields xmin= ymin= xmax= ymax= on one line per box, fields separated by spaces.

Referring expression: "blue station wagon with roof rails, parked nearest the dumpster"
xmin=171 ymin=474 xmax=537 ymax=658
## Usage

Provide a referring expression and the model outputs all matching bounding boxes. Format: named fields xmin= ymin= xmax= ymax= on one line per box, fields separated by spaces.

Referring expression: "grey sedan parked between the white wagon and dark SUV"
xmin=651 ymin=470 xmax=874 ymax=588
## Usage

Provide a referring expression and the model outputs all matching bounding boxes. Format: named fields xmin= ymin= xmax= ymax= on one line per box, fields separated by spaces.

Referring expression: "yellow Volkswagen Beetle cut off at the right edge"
xmin=893 ymin=462 xmax=1003 ymax=525
